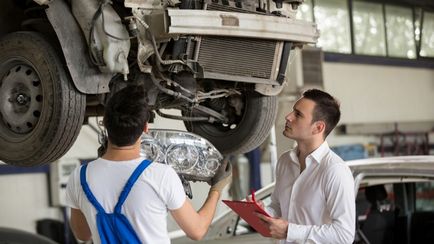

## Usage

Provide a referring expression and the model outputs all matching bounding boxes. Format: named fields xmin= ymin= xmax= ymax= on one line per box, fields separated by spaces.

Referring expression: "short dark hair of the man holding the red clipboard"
xmin=303 ymin=89 xmax=341 ymax=138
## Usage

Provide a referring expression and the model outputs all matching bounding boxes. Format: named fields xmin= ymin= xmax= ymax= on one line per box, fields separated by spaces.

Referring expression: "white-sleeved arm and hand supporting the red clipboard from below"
xmin=258 ymin=165 xmax=356 ymax=243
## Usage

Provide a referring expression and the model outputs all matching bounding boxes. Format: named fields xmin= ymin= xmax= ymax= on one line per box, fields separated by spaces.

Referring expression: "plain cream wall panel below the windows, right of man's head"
xmin=323 ymin=63 xmax=434 ymax=124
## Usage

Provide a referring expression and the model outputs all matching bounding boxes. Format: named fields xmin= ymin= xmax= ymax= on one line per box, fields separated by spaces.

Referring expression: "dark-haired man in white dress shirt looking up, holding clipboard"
xmin=259 ymin=89 xmax=356 ymax=244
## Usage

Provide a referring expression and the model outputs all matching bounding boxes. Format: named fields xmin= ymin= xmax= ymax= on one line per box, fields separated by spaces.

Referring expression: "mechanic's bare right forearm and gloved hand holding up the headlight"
xmin=170 ymin=160 xmax=232 ymax=240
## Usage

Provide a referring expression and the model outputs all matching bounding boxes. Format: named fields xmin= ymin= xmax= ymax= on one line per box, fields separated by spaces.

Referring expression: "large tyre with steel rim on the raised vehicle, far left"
xmin=0 ymin=32 xmax=86 ymax=166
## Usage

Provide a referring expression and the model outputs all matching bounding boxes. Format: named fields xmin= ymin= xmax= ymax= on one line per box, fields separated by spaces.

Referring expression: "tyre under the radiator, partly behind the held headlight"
xmin=184 ymin=91 xmax=277 ymax=154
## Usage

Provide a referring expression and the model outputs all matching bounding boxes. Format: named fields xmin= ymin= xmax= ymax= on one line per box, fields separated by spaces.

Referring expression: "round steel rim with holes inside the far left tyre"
xmin=0 ymin=60 xmax=43 ymax=135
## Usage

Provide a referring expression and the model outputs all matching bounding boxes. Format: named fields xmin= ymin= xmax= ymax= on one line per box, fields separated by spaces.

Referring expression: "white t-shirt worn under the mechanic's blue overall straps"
xmin=66 ymin=158 xmax=186 ymax=243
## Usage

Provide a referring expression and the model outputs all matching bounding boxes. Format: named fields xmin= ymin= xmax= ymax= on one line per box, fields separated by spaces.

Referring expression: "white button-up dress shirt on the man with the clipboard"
xmin=267 ymin=142 xmax=356 ymax=244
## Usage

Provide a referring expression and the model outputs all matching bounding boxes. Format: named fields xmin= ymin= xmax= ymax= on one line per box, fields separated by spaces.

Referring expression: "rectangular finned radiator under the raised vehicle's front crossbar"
xmin=198 ymin=37 xmax=277 ymax=79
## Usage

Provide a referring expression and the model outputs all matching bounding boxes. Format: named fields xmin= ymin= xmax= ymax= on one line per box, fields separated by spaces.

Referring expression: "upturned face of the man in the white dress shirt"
xmin=283 ymin=98 xmax=315 ymax=141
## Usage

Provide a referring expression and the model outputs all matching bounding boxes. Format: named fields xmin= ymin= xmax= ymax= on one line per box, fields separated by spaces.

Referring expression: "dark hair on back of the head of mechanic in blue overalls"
xmin=104 ymin=85 xmax=149 ymax=147
